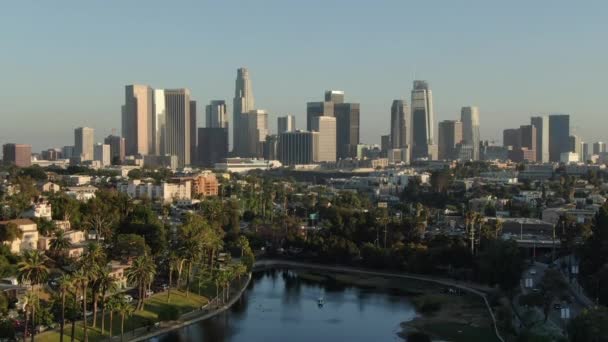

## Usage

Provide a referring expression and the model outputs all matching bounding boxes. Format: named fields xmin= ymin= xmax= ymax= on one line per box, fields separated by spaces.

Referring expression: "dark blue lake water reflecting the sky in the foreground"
xmin=151 ymin=269 xmax=416 ymax=342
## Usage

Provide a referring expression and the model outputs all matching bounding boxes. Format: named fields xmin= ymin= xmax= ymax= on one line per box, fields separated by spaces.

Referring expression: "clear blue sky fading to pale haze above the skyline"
xmin=0 ymin=0 xmax=608 ymax=151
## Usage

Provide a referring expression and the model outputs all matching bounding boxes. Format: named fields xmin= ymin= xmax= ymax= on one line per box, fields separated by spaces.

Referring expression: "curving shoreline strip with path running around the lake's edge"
xmin=127 ymin=259 xmax=504 ymax=342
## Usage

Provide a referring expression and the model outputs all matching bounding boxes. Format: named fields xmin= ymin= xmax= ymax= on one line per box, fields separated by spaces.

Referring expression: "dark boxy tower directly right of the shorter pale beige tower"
xmin=334 ymin=103 xmax=360 ymax=159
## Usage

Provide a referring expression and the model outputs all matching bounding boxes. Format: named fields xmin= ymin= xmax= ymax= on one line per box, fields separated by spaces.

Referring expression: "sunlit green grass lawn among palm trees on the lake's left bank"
xmin=36 ymin=290 xmax=208 ymax=342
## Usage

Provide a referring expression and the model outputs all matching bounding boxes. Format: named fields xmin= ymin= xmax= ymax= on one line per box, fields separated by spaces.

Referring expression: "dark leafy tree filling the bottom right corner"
xmin=568 ymin=306 xmax=608 ymax=342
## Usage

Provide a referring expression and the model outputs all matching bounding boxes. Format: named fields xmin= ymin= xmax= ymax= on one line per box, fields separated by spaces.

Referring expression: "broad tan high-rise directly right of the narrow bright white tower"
xmin=165 ymin=89 xmax=191 ymax=167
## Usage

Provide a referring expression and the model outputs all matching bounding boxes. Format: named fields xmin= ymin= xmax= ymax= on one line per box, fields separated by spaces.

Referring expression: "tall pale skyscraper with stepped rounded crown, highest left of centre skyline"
xmin=232 ymin=68 xmax=255 ymax=155
